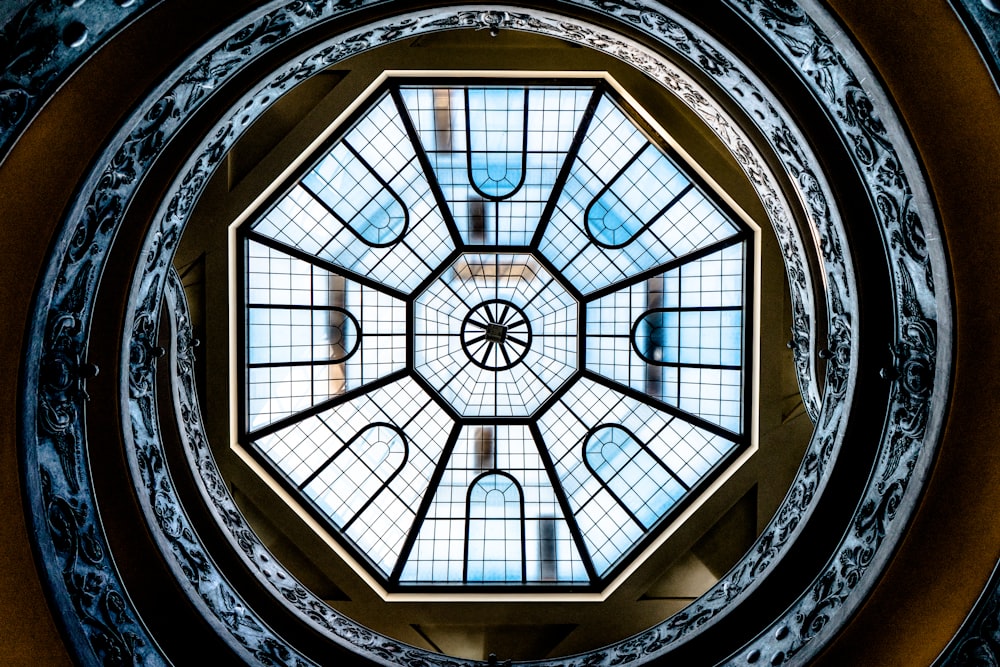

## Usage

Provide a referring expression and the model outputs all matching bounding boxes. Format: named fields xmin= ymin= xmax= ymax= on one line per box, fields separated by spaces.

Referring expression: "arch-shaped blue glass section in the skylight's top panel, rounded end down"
xmin=465 ymin=87 xmax=528 ymax=200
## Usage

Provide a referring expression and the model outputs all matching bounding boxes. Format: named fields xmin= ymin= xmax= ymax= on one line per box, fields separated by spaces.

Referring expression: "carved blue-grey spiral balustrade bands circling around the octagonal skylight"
xmin=22 ymin=0 xmax=951 ymax=666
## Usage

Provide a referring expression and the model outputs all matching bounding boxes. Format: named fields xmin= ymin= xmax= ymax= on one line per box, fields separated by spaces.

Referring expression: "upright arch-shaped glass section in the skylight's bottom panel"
xmin=465 ymin=472 xmax=526 ymax=582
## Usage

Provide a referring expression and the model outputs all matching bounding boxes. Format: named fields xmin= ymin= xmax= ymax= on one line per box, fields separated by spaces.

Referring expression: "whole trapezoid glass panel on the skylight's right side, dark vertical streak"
xmin=586 ymin=242 xmax=746 ymax=433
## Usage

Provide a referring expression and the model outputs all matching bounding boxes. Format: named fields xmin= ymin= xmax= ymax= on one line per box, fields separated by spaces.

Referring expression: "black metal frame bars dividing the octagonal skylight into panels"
xmin=237 ymin=78 xmax=755 ymax=593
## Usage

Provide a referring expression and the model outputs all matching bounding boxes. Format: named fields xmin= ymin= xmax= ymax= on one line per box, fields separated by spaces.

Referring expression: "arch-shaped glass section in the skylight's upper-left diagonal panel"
xmin=301 ymin=139 xmax=410 ymax=248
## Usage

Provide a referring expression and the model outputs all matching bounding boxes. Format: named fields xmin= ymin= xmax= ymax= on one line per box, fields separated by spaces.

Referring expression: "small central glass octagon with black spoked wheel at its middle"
xmin=413 ymin=253 xmax=579 ymax=417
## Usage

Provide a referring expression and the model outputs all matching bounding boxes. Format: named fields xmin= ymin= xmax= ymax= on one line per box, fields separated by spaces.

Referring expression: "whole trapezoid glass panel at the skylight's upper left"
xmin=251 ymin=95 xmax=454 ymax=291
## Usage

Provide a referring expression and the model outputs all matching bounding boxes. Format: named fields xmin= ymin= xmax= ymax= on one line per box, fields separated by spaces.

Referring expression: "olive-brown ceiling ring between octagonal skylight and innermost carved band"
xmin=175 ymin=31 xmax=812 ymax=659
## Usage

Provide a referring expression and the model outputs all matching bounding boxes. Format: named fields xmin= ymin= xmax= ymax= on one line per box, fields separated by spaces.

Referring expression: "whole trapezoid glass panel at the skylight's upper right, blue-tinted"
xmin=539 ymin=95 xmax=739 ymax=294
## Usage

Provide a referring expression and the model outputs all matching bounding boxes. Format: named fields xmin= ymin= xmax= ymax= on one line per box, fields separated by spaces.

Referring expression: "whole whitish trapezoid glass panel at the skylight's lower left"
xmin=253 ymin=379 xmax=452 ymax=576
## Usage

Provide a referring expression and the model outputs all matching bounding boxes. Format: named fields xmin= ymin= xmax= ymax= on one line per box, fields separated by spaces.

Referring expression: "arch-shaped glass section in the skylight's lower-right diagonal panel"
xmin=583 ymin=425 xmax=688 ymax=530
